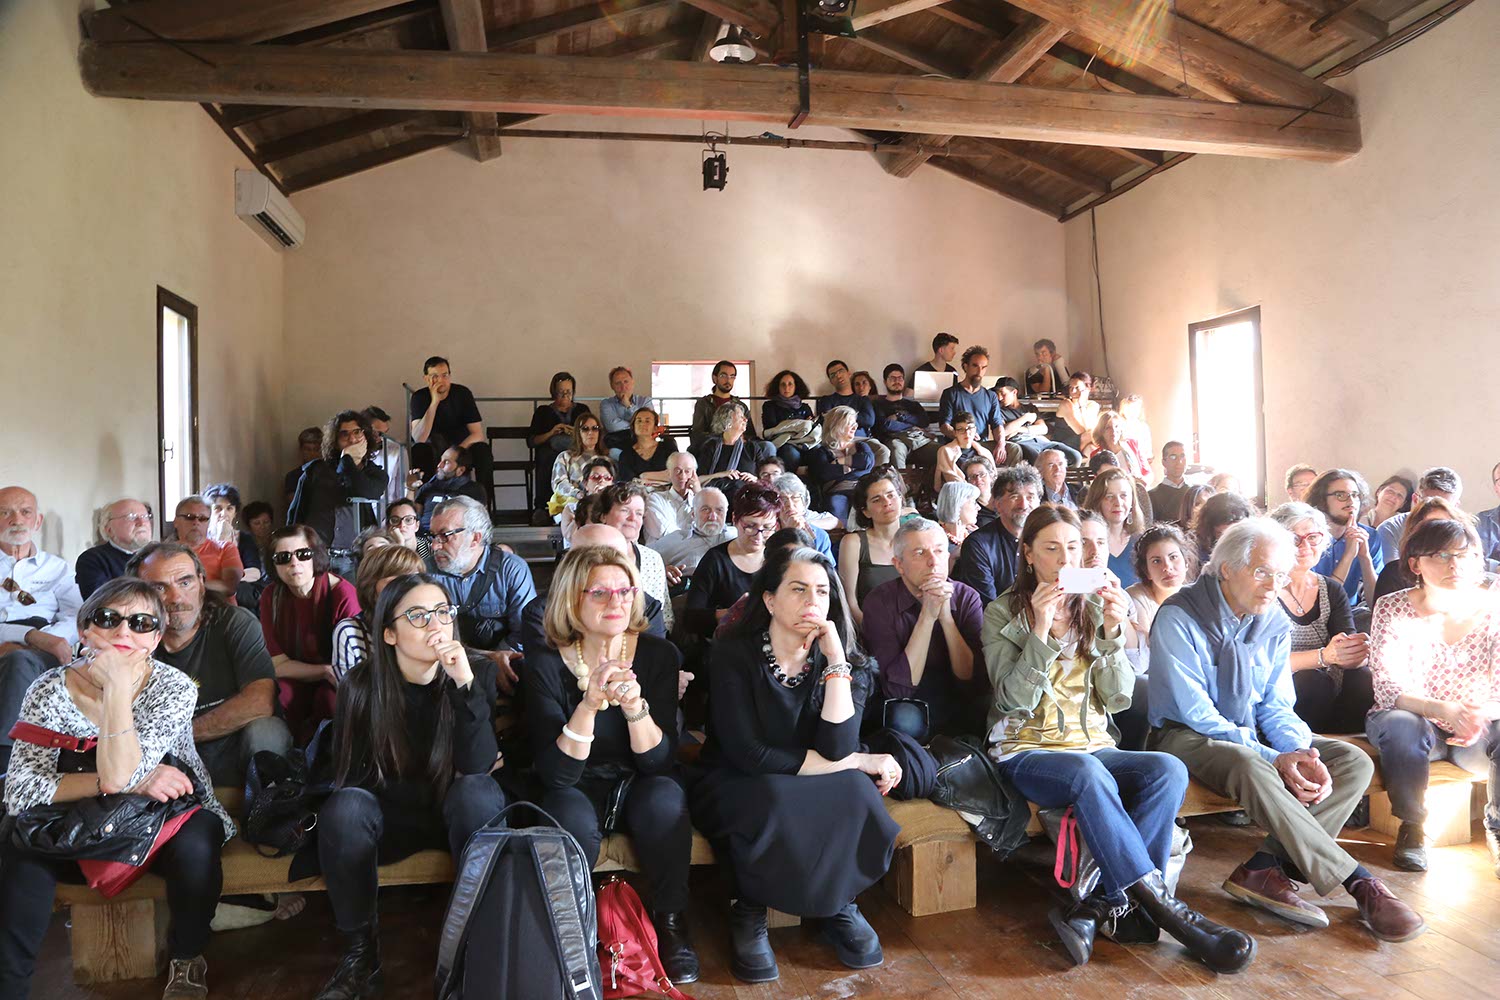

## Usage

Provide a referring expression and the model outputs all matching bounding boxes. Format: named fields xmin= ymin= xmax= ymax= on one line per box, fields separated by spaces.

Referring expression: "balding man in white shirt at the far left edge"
xmin=0 ymin=486 xmax=84 ymax=771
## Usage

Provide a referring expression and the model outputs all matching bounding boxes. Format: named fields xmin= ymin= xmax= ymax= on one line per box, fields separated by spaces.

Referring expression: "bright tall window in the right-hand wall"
xmin=1188 ymin=306 xmax=1266 ymax=499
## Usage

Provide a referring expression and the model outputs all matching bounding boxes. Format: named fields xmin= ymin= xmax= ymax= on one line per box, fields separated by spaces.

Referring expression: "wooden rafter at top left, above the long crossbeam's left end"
xmin=83 ymin=0 xmax=411 ymax=45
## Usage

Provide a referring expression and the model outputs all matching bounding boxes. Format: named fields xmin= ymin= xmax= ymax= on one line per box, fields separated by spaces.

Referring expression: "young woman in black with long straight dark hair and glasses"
xmin=317 ymin=573 xmax=506 ymax=1000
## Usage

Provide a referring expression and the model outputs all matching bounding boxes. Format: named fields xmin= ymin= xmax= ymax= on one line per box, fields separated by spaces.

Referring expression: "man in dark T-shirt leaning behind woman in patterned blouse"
xmin=126 ymin=541 xmax=291 ymax=786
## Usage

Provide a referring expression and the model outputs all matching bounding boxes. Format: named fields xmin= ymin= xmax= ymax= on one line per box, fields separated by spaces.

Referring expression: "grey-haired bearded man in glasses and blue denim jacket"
xmin=429 ymin=496 xmax=537 ymax=694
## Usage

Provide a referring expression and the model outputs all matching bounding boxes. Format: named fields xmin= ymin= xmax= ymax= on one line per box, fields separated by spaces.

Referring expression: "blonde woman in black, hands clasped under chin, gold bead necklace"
xmin=525 ymin=546 xmax=698 ymax=984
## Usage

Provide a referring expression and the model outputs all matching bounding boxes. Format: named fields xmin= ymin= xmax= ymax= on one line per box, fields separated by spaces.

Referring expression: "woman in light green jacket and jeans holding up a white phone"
xmin=981 ymin=505 xmax=1256 ymax=973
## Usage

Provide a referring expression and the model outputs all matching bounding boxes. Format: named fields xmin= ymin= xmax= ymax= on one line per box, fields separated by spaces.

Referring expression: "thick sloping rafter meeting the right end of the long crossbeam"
xmin=1011 ymin=0 xmax=1355 ymax=115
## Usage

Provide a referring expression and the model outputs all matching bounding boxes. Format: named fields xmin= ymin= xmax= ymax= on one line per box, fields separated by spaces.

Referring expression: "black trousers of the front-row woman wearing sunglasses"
xmin=0 ymin=810 xmax=224 ymax=1000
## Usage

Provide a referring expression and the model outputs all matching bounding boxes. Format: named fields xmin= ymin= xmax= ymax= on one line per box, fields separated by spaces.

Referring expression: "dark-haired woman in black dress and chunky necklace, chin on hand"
xmin=693 ymin=547 xmax=902 ymax=982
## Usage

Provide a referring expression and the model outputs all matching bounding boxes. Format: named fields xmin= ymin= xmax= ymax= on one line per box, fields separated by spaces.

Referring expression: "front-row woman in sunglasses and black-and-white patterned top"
xmin=0 ymin=579 xmax=234 ymax=1000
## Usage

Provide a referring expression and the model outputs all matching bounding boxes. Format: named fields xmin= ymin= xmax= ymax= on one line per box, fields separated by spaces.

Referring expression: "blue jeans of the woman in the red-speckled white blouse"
xmin=1365 ymin=709 xmax=1500 ymax=831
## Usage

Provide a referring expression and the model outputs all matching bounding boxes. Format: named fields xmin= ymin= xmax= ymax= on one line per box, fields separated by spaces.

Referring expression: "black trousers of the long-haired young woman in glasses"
xmin=318 ymin=774 xmax=506 ymax=931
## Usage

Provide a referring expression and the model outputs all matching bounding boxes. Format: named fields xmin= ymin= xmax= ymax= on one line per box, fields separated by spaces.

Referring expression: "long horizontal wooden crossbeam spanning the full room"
xmin=78 ymin=40 xmax=1361 ymax=160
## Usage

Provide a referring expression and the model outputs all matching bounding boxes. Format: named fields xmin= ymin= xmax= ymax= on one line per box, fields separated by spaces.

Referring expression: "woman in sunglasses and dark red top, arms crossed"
xmin=261 ymin=525 xmax=360 ymax=745
